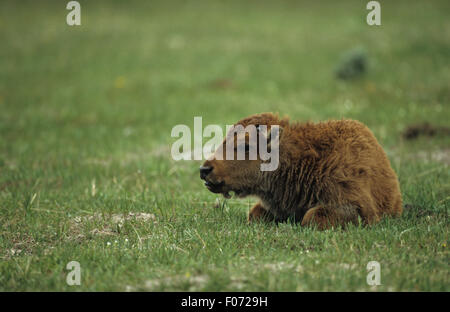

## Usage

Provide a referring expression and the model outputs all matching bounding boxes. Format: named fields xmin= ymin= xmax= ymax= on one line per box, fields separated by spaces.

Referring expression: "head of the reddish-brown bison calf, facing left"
xmin=200 ymin=113 xmax=287 ymax=198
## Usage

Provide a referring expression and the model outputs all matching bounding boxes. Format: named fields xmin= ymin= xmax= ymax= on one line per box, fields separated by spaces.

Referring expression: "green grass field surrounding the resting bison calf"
xmin=0 ymin=0 xmax=450 ymax=291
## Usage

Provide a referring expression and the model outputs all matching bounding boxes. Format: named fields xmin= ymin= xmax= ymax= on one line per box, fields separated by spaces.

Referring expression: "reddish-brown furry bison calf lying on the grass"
xmin=200 ymin=113 xmax=402 ymax=229
